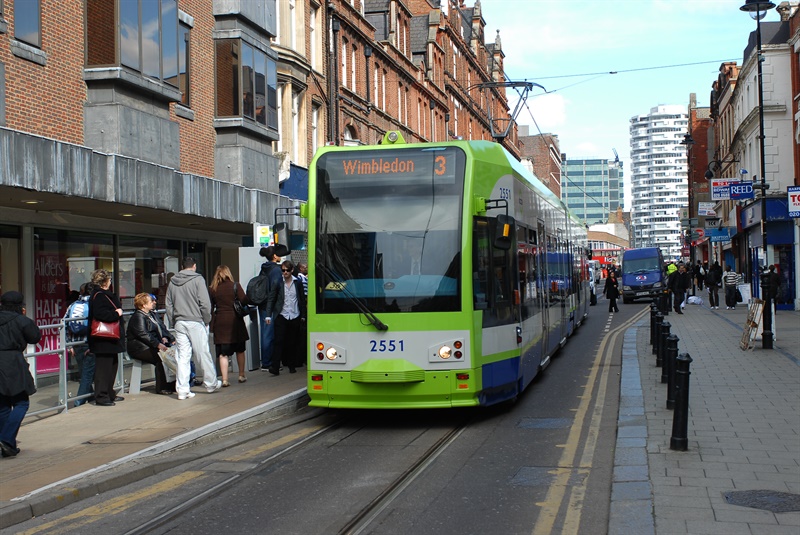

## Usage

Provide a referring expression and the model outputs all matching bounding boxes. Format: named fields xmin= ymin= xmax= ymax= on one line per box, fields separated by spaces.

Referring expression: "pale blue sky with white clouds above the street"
xmin=476 ymin=0 xmax=780 ymax=210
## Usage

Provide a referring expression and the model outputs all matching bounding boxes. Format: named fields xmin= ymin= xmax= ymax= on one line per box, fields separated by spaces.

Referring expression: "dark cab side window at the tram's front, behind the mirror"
xmin=473 ymin=218 xmax=516 ymax=327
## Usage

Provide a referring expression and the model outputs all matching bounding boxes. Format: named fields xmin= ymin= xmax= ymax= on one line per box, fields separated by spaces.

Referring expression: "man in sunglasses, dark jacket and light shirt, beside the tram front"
xmin=267 ymin=260 xmax=306 ymax=375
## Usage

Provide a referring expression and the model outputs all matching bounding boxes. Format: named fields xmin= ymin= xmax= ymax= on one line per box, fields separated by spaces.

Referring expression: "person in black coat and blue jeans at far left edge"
xmin=0 ymin=291 xmax=42 ymax=457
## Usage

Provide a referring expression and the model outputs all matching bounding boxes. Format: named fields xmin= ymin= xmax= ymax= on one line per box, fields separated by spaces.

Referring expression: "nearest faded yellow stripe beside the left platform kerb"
xmin=18 ymin=471 xmax=205 ymax=535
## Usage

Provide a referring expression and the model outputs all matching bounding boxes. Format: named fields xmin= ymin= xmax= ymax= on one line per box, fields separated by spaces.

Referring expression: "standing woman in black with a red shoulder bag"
xmin=88 ymin=269 xmax=125 ymax=407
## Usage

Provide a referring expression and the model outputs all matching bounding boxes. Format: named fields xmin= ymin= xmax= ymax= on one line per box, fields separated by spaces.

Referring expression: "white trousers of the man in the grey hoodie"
xmin=175 ymin=320 xmax=217 ymax=395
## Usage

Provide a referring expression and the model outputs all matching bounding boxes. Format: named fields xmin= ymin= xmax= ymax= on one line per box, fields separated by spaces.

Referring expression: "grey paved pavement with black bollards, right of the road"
xmin=608 ymin=305 xmax=800 ymax=535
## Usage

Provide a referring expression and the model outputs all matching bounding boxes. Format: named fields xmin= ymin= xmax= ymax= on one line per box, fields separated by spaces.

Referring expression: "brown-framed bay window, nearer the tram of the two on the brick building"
xmin=216 ymin=39 xmax=278 ymax=131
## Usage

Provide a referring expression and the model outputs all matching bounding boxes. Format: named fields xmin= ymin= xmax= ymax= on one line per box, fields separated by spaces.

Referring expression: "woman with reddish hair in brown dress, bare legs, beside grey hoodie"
xmin=209 ymin=265 xmax=250 ymax=387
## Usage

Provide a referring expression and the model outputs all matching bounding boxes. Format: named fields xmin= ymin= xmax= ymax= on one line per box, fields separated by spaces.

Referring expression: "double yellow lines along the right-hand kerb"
xmin=533 ymin=311 xmax=646 ymax=535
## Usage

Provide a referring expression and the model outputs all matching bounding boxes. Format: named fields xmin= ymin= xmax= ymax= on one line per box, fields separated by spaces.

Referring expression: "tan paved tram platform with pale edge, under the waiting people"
xmin=0 ymin=368 xmax=307 ymax=529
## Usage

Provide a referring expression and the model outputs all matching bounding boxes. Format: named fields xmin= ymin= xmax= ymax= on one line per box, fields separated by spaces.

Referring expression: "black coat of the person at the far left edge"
xmin=0 ymin=310 xmax=42 ymax=397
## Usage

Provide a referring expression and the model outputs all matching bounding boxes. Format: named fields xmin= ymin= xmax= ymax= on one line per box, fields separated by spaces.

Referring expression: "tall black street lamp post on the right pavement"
xmin=739 ymin=0 xmax=775 ymax=349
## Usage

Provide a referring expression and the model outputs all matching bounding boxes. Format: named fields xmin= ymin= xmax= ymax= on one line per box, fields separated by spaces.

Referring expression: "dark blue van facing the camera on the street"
xmin=620 ymin=247 xmax=667 ymax=303
